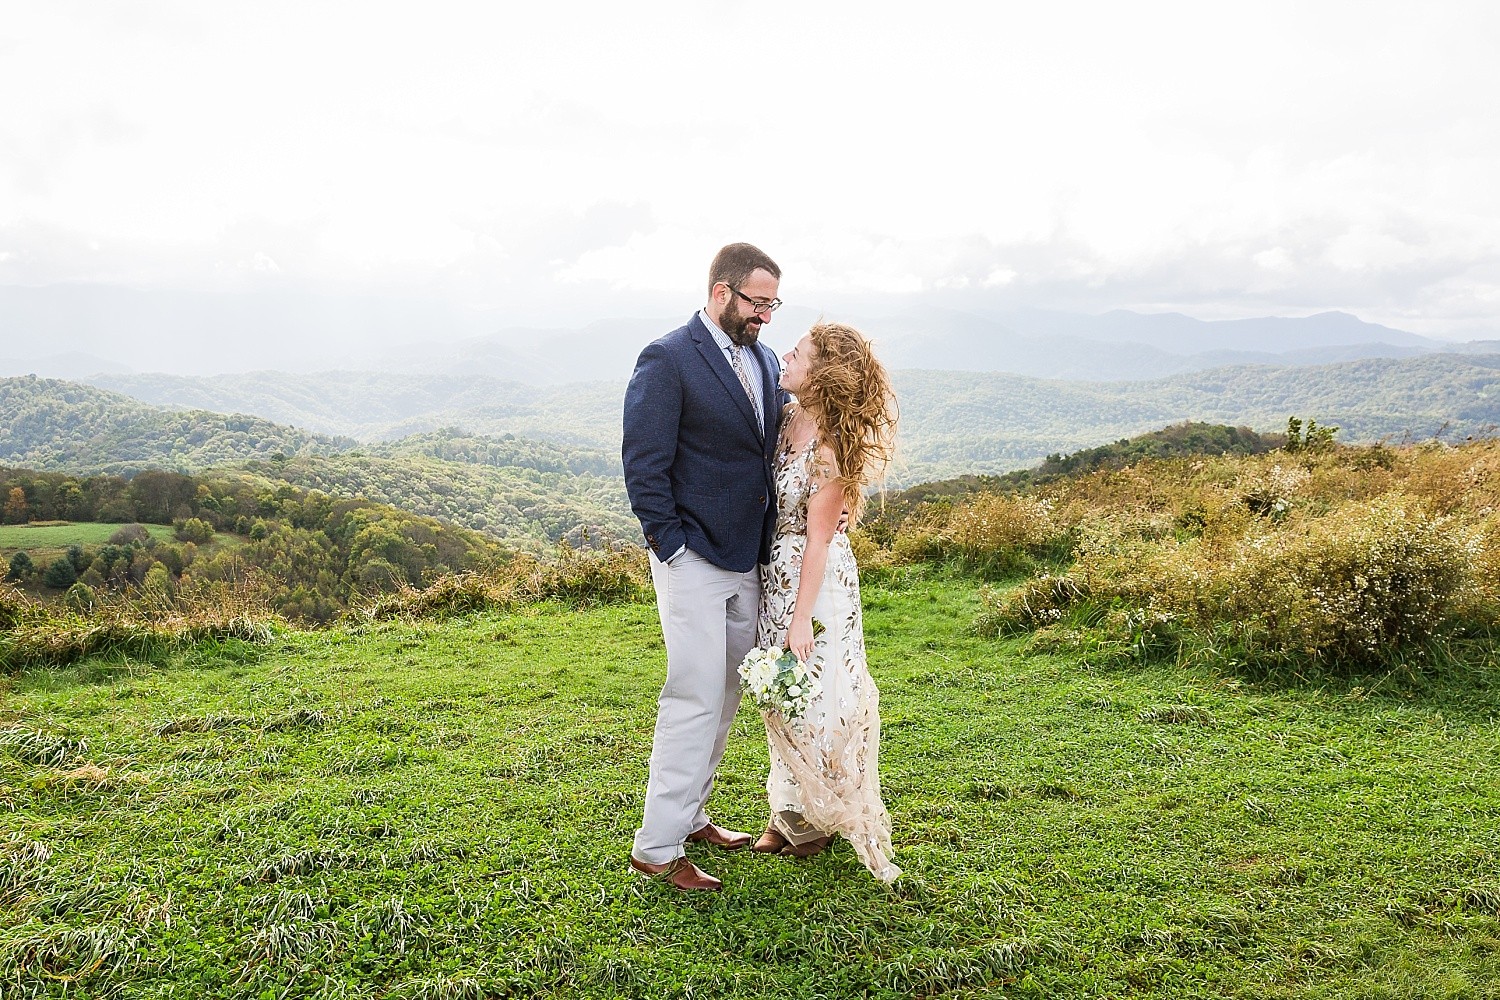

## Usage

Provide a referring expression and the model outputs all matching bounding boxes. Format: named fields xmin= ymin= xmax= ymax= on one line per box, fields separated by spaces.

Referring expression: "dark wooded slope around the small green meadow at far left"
xmin=0 ymin=468 xmax=509 ymax=621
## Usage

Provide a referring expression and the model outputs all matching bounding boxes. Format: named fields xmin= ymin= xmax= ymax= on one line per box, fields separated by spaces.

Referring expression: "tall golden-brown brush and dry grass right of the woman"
xmin=924 ymin=441 xmax=1500 ymax=669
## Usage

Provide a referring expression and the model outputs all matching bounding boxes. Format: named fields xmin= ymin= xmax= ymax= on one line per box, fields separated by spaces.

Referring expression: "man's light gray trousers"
xmin=630 ymin=549 xmax=761 ymax=865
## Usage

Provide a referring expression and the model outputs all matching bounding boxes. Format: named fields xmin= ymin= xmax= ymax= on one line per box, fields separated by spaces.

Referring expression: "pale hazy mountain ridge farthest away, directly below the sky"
xmin=0 ymin=283 xmax=1500 ymax=385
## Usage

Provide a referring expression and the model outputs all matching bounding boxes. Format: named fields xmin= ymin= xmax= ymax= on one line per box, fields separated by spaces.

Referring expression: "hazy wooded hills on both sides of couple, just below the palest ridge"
xmin=85 ymin=354 xmax=1500 ymax=486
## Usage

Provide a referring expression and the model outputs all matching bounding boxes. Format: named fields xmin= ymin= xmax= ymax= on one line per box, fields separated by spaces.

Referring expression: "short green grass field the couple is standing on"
xmin=0 ymin=570 xmax=1500 ymax=999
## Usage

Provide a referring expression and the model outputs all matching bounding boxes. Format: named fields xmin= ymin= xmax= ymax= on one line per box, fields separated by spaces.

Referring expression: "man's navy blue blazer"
xmin=621 ymin=313 xmax=788 ymax=573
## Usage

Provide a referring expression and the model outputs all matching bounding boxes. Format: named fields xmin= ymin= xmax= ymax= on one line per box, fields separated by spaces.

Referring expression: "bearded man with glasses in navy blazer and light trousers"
xmin=621 ymin=243 xmax=788 ymax=889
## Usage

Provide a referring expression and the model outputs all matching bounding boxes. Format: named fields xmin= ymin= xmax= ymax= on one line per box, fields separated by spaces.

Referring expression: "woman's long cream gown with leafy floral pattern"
xmin=756 ymin=417 xmax=902 ymax=882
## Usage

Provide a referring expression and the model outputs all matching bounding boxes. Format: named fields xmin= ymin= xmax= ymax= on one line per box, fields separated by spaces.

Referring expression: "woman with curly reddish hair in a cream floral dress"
xmin=755 ymin=324 xmax=900 ymax=882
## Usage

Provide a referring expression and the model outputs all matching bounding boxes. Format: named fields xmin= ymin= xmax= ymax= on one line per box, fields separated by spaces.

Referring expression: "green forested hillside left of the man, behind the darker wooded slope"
xmin=0 ymin=379 xmax=639 ymax=550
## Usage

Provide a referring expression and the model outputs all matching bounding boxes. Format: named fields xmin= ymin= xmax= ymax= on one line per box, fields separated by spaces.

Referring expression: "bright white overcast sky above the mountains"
xmin=0 ymin=0 xmax=1500 ymax=347
